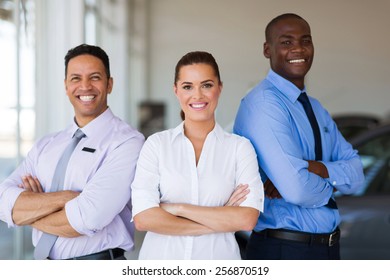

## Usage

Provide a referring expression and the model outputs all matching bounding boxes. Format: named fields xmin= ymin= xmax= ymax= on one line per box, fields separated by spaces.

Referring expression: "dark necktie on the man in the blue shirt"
xmin=298 ymin=92 xmax=337 ymax=209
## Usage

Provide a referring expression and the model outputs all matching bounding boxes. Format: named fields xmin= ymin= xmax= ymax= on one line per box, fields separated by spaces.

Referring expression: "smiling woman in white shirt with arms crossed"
xmin=132 ymin=52 xmax=264 ymax=259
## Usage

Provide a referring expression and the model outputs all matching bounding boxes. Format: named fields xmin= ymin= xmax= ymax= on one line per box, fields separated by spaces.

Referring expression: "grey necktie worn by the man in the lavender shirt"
xmin=34 ymin=129 xmax=85 ymax=260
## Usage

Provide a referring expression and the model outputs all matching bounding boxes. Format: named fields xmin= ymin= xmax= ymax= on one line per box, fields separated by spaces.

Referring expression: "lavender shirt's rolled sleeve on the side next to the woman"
xmin=65 ymin=139 xmax=143 ymax=236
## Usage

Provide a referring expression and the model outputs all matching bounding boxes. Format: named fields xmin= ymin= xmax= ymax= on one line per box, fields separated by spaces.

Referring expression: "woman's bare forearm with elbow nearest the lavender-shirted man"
xmin=134 ymin=207 xmax=213 ymax=235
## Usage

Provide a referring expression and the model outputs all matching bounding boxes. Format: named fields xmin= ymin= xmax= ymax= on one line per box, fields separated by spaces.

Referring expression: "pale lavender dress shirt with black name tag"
xmin=0 ymin=109 xmax=144 ymax=259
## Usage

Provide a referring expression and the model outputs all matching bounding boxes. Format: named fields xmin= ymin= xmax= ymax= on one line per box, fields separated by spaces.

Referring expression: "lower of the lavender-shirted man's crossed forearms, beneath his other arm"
xmin=31 ymin=209 xmax=80 ymax=238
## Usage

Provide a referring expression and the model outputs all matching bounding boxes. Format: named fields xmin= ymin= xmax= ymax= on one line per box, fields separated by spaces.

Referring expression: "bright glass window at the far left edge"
xmin=0 ymin=0 xmax=35 ymax=259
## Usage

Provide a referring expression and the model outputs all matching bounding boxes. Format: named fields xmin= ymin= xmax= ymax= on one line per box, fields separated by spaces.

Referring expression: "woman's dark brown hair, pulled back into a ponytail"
xmin=174 ymin=51 xmax=221 ymax=120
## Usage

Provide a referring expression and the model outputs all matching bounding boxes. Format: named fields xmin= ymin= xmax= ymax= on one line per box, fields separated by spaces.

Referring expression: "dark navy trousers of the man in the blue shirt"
xmin=245 ymin=233 xmax=340 ymax=260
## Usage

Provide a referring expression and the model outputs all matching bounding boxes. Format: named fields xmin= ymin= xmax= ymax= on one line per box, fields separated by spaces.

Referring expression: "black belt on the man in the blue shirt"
xmin=253 ymin=228 xmax=340 ymax=247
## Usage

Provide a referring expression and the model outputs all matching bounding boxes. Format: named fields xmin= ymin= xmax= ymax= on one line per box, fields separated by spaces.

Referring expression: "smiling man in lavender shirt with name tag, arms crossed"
xmin=0 ymin=44 xmax=144 ymax=259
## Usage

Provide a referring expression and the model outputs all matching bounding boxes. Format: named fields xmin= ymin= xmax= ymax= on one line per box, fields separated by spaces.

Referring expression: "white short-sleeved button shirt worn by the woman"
xmin=132 ymin=123 xmax=264 ymax=259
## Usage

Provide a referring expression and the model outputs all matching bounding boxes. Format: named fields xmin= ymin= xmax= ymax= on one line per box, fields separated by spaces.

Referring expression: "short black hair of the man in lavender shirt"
xmin=65 ymin=44 xmax=111 ymax=78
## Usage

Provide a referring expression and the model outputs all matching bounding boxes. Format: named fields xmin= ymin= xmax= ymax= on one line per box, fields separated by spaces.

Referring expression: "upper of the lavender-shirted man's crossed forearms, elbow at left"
xmin=12 ymin=191 xmax=78 ymax=225
